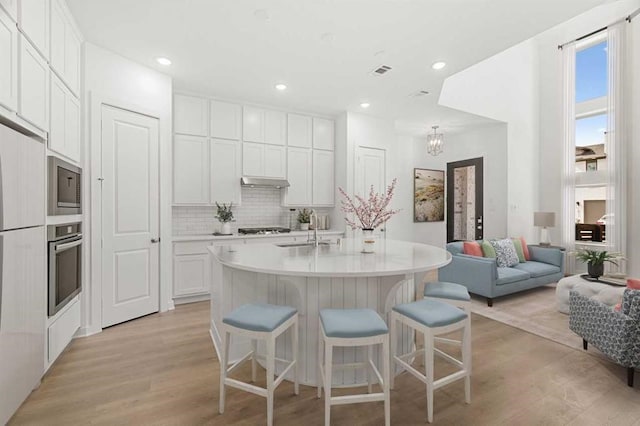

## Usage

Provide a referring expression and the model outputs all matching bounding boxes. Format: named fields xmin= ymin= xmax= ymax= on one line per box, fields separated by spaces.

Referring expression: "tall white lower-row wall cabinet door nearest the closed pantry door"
xmin=173 ymin=135 xmax=210 ymax=204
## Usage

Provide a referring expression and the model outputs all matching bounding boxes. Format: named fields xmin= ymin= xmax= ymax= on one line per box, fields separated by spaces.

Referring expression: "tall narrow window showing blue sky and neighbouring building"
xmin=575 ymin=34 xmax=608 ymax=243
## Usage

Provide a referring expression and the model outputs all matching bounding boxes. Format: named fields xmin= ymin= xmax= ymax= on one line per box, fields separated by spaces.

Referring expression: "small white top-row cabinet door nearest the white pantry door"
xmin=173 ymin=94 xmax=209 ymax=136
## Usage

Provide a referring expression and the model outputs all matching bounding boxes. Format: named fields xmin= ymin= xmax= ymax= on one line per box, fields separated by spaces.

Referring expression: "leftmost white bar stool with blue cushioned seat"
xmin=219 ymin=304 xmax=299 ymax=426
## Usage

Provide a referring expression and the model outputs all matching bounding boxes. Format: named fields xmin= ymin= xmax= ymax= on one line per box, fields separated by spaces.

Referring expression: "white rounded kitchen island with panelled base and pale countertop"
xmin=209 ymin=239 xmax=451 ymax=386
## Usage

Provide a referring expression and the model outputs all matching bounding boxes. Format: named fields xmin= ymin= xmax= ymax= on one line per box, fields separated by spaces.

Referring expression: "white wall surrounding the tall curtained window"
xmin=535 ymin=0 xmax=640 ymax=276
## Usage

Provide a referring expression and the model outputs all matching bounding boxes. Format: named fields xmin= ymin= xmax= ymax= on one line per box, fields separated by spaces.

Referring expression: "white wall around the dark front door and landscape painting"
xmin=410 ymin=124 xmax=508 ymax=246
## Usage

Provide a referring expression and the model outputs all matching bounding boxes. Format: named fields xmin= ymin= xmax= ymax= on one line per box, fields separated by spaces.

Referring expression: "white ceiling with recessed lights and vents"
xmin=67 ymin=0 xmax=608 ymax=134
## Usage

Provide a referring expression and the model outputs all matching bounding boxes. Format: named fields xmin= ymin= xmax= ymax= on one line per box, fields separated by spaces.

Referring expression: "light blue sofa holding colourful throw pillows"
xmin=438 ymin=241 xmax=564 ymax=306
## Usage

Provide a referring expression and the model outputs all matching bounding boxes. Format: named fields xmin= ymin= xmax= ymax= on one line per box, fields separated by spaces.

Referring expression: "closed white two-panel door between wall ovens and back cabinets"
xmin=101 ymin=105 xmax=160 ymax=327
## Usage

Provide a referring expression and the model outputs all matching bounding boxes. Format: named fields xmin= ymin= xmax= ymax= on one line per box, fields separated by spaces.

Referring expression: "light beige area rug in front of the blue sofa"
xmin=464 ymin=284 xmax=582 ymax=349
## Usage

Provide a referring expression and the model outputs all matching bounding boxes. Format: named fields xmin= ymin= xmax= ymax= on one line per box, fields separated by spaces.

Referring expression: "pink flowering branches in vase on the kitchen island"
xmin=338 ymin=179 xmax=400 ymax=253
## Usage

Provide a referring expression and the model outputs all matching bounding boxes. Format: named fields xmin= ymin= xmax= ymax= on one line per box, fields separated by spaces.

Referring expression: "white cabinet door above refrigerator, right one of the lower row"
xmin=18 ymin=36 xmax=49 ymax=131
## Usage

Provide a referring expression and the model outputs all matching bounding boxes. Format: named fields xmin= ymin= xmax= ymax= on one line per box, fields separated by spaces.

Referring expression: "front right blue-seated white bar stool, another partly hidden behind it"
xmin=390 ymin=299 xmax=471 ymax=423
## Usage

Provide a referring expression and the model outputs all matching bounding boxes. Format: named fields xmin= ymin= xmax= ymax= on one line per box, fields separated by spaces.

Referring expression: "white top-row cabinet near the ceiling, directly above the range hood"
xmin=242 ymin=106 xmax=287 ymax=145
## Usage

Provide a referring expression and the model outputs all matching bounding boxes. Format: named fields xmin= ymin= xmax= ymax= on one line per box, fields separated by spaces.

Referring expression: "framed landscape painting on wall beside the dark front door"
xmin=413 ymin=169 xmax=445 ymax=222
